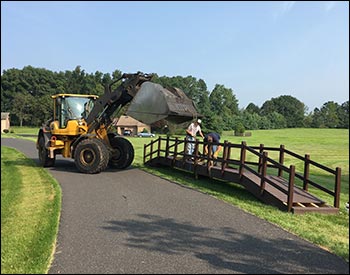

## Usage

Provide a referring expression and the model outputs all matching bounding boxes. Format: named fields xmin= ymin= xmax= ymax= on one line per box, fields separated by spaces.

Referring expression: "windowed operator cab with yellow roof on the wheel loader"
xmin=52 ymin=94 xmax=98 ymax=129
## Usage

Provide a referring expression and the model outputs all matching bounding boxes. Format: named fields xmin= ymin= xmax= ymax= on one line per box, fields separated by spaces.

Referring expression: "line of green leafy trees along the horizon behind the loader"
xmin=1 ymin=66 xmax=349 ymax=133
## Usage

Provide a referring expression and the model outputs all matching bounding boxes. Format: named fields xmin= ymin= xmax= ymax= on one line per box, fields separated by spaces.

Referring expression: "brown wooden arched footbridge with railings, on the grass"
xmin=143 ymin=137 xmax=341 ymax=214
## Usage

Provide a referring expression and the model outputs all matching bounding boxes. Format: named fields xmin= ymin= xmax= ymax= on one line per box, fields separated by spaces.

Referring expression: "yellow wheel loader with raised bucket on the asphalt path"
xmin=36 ymin=72 xmax=199 ymax=174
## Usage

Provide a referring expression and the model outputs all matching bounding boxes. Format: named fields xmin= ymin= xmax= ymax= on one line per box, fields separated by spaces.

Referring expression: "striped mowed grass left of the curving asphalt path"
xmin=1 ymin=147 xmax=61 ymax=274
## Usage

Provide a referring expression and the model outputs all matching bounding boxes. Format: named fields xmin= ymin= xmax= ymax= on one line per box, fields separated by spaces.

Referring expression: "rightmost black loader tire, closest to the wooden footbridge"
xmin=108 ymin=134 xmax=134 ymax=169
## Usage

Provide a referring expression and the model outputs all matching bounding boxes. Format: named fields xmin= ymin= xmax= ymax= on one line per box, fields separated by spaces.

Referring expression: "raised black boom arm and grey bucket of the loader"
xmin=85 ymin=72 xmax=201 ymax=133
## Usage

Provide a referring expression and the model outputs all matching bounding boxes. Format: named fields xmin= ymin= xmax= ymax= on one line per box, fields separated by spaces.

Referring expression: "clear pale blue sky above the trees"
xmin=1 ymin=1 xmax=349 ymax=111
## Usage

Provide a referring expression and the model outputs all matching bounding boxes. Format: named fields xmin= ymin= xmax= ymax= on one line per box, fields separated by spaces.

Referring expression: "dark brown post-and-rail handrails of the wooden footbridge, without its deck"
xmin=144 ymin=137 xmax=341 ymax=208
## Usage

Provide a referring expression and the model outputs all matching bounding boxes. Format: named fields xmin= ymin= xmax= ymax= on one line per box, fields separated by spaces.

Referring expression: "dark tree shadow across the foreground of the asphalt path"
xmin=102 ymin=214 xmax=349 ymax=274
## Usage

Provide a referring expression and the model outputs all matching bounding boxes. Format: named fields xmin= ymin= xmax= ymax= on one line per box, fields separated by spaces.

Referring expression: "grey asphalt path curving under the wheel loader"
xmin=1 ymin=138 xmax=349 ymax=274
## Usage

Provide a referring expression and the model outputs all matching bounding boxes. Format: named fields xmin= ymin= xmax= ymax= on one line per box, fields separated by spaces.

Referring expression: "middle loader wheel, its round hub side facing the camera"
xmin=74 ymin=138 xmax=109 ymax=174
